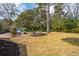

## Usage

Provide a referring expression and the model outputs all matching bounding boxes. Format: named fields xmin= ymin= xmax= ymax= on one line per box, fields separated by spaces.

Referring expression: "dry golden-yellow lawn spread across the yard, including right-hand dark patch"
xmin=11 ymin=32 xmax=79 ymax=56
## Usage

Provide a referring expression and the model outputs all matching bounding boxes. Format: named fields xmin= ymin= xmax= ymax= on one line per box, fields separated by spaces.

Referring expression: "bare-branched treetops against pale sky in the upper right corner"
xmin=64 ymin=3 xmax=79 ymax=19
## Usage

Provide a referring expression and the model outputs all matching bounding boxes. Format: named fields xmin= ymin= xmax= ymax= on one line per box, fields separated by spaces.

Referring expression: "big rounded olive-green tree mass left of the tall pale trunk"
xmin=15 ymin=8 xmax=46 ymax=31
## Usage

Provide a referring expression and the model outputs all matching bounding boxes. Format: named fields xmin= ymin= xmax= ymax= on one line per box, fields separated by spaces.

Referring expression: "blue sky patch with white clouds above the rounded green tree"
xmin=13 ymin=3 xmax=36 ymax=20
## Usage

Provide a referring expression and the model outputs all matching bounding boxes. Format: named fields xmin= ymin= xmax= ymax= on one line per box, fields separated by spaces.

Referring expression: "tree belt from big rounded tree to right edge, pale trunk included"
xmin=16 ymin=3 xmax=78 ymax=32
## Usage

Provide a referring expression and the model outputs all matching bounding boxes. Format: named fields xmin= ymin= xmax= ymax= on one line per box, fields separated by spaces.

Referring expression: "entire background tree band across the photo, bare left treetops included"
xmin=0 ymin=3 xmax=79 ymax=32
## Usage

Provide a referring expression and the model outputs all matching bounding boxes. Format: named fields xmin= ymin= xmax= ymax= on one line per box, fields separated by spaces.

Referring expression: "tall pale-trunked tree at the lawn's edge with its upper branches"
xmin=38 ymin=3 xmax=56 ymax=33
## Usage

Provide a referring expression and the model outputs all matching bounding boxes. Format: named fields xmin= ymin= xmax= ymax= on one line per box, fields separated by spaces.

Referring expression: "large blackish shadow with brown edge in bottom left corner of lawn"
xmin=0 ymin=38 xmax=27 ymax=56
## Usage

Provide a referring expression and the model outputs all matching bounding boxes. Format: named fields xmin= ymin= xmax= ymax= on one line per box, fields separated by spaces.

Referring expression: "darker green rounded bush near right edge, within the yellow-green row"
xmin=64 ymin=19 xmax=77 ymax=32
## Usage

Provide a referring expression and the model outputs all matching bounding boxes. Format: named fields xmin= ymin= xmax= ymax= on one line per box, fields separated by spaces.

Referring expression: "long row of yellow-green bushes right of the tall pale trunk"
xmin=52 ymin=18 xmax=79 ymax=33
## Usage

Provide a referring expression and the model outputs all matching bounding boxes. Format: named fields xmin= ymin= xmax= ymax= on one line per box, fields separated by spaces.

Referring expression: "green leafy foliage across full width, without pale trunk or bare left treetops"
xmin=0 ymin=3 xmax=79 ymax=33
